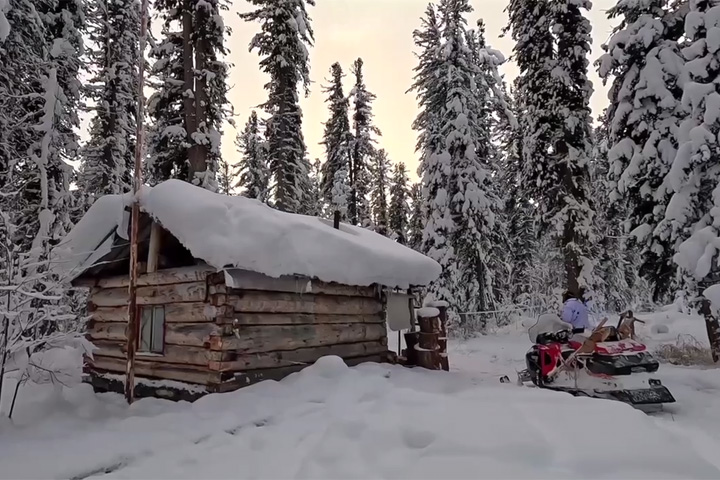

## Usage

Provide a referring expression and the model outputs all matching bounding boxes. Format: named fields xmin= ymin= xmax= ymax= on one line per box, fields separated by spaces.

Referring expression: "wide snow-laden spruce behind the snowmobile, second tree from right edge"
xmin=597 ymin=0 xmax=687 ymax=301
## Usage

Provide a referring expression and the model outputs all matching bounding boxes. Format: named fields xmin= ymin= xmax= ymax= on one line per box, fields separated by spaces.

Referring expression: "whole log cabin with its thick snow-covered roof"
xmin=54 ymin=180 xmax=440 ymax=400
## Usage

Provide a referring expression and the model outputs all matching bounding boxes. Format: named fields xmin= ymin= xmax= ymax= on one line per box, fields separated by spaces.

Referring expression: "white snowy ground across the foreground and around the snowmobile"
xmin=0 ymin=313 xmax=720 ymax=479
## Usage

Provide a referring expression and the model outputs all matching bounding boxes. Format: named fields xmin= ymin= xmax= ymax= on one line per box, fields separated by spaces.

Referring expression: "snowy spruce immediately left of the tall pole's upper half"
xmin=78 ymin=0 xmax=140 ymax=197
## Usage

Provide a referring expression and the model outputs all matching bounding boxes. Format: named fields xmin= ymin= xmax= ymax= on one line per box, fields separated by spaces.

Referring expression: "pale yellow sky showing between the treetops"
xmin=223 ymin=0 xmax=615 ymax=178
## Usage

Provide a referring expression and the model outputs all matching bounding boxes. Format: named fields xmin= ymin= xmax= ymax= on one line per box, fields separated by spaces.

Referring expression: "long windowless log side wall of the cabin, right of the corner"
xmin=209 ymin=272 xmax=388 ymax=390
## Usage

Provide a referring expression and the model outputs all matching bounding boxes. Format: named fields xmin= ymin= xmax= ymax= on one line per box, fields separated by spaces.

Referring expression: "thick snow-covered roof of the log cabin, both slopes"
xmin=55 ymin=180 xmax=440 ymax=288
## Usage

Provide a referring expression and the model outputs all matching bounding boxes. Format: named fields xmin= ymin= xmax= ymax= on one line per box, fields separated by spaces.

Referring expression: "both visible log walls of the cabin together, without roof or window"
xmin=81 ymin=267 xmax=388 ymax=391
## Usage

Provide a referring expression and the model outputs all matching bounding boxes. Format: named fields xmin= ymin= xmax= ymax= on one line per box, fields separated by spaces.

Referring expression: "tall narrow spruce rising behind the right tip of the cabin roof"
xmin=410 ymin=4 xmax=458 ymax=316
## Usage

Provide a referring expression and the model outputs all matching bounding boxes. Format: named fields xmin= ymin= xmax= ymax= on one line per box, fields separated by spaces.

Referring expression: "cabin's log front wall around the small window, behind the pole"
xmin=81 ymin=266 xmax=227 ymax=386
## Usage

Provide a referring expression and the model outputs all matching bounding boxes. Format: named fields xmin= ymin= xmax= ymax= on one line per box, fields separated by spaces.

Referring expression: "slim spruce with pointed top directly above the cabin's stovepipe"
xmin=321 ymin=63 xmax=354 ymax=205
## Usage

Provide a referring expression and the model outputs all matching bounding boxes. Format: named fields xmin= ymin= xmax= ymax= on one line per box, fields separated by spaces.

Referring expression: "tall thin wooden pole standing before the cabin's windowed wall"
xmin=125 ymin=0 xmax=148 ymax=403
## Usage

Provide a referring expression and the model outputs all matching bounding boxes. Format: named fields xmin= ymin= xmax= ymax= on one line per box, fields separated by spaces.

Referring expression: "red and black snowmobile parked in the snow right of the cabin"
xmin=500 ymin=313 xmax=675 ymax=409
